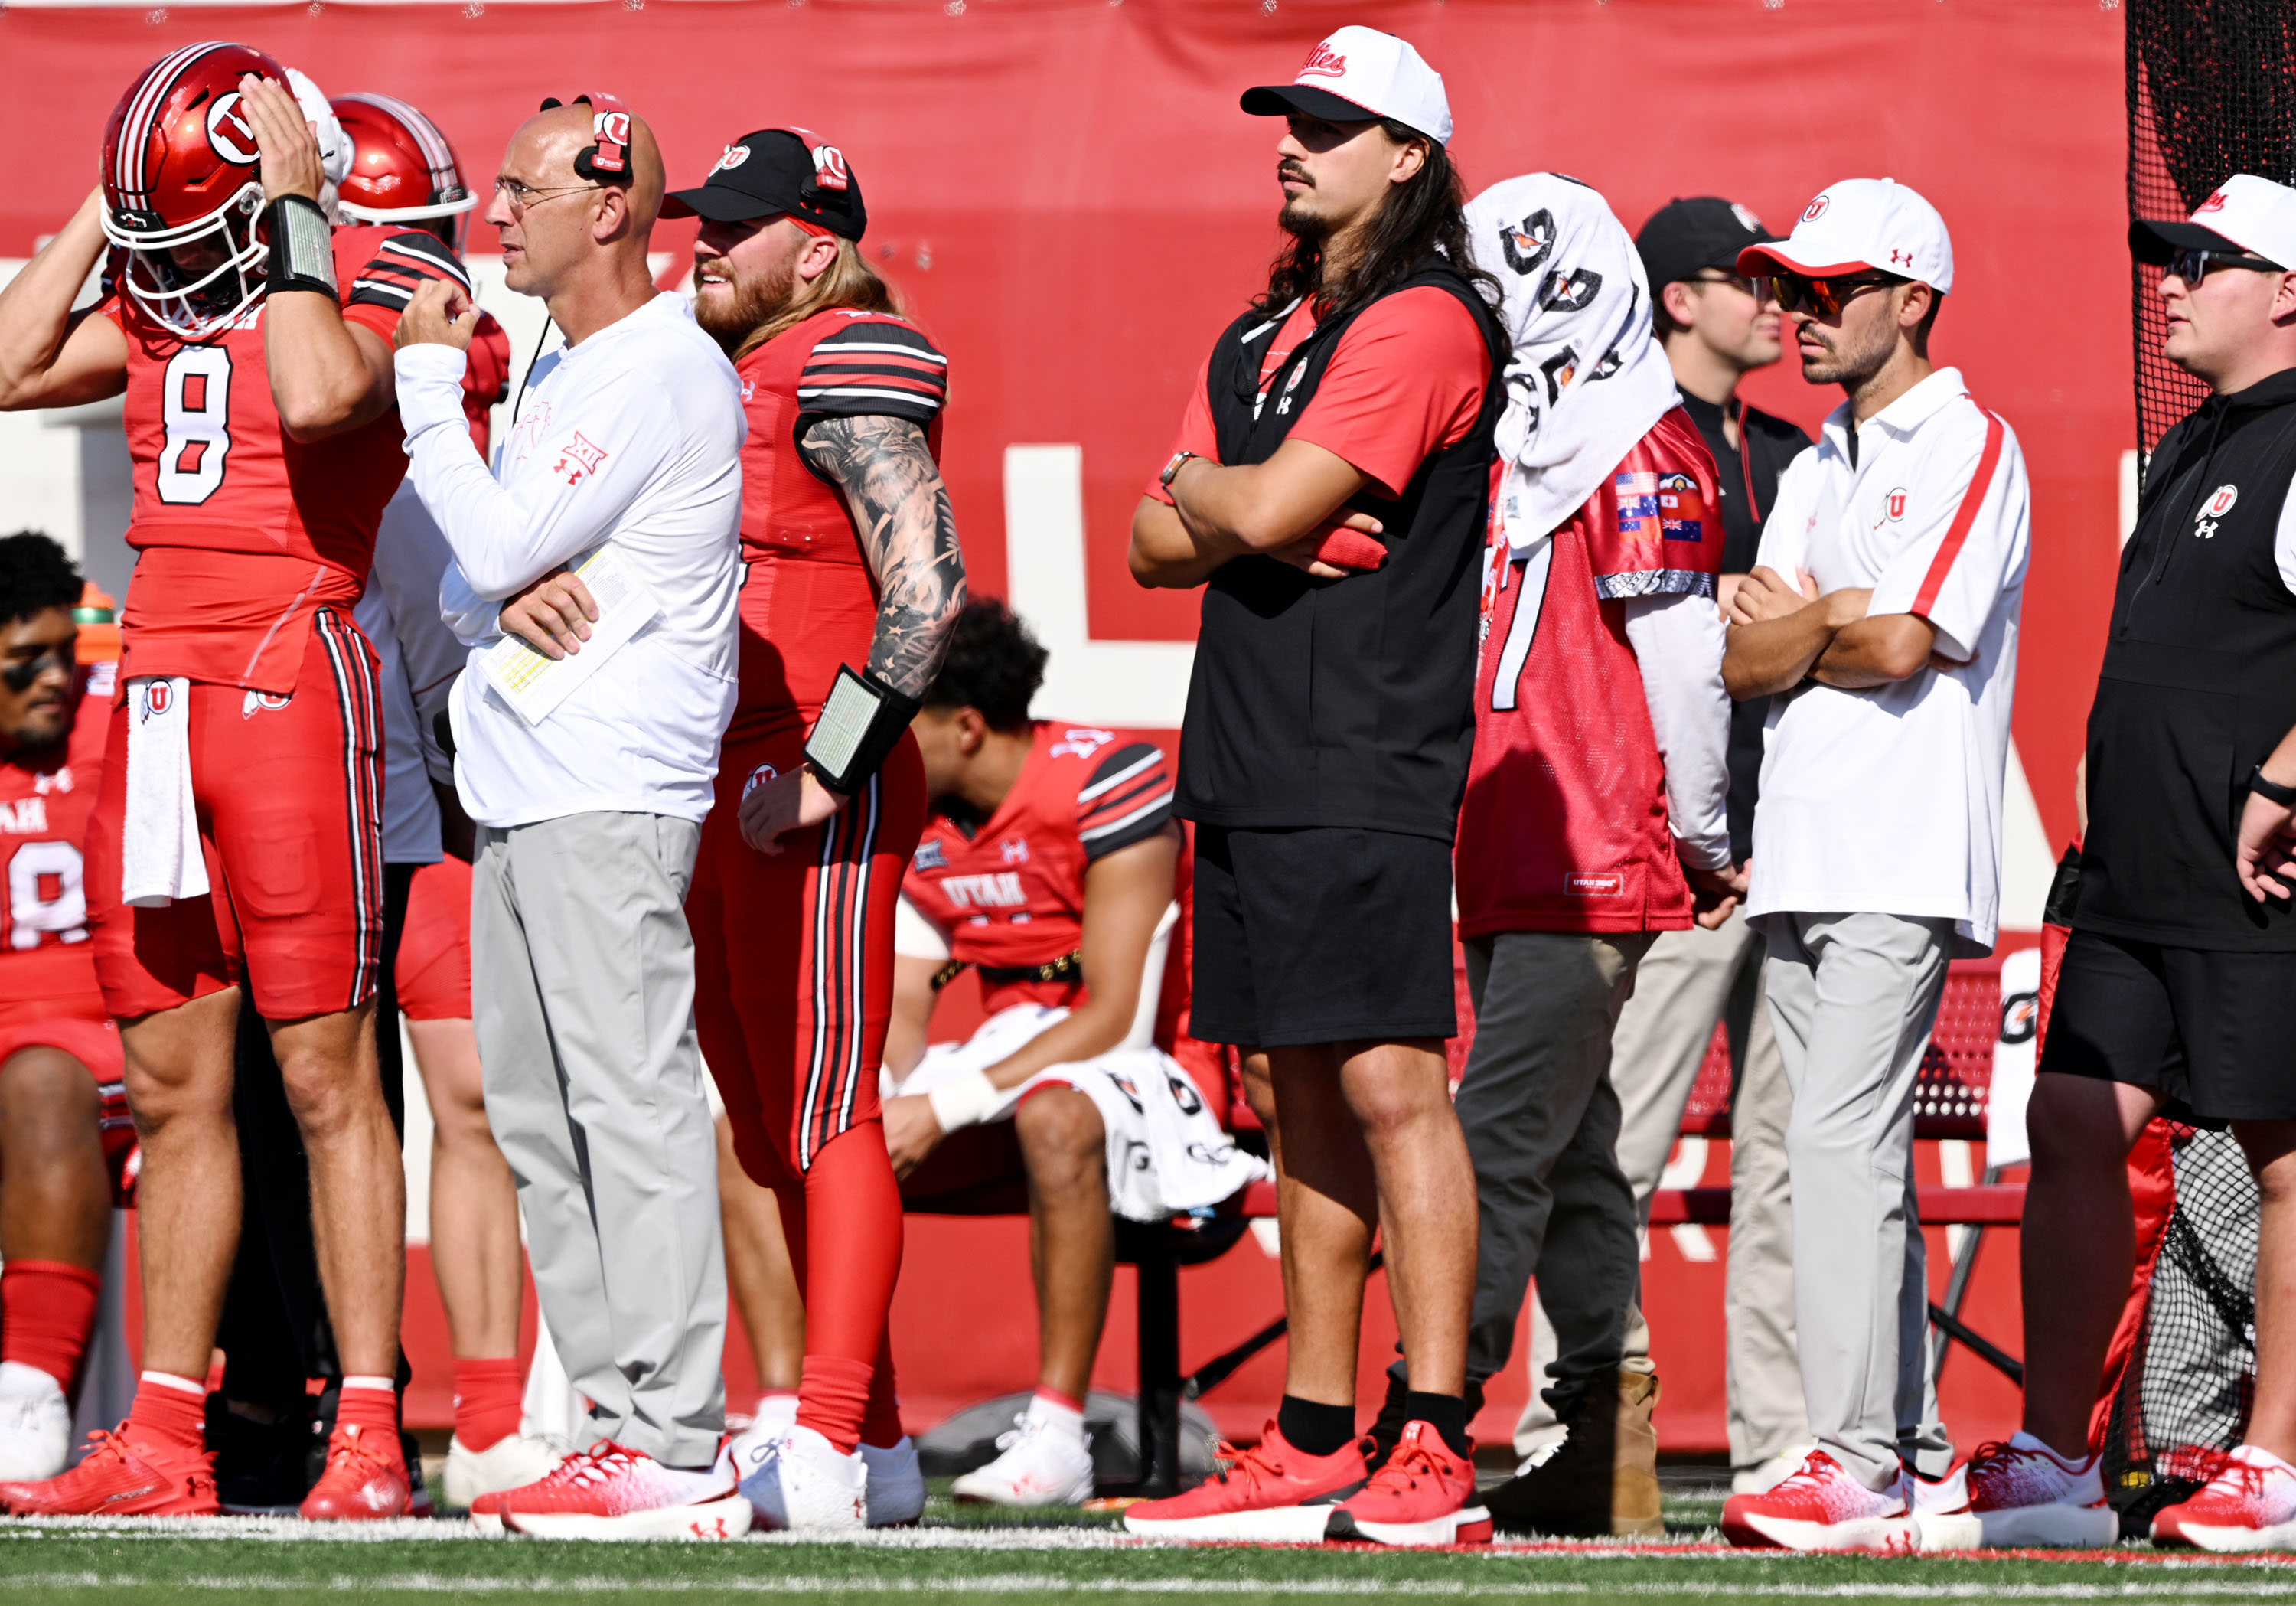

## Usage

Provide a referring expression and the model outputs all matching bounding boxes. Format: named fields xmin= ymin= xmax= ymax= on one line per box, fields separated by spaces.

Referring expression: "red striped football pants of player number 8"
xmin=87 ymin=609 xmax=383 ymax=1020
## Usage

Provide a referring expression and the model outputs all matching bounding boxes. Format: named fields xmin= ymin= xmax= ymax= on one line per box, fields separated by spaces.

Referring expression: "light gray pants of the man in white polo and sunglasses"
xmin=1763 ymin=915 xmax=1954 ymax=1489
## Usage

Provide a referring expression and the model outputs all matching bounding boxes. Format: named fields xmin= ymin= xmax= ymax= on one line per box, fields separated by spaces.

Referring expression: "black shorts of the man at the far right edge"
xmin=2041 ymin=931 xmax=2296 ymax=1126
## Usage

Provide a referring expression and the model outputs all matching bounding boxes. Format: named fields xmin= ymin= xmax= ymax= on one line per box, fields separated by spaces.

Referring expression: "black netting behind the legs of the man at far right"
xmin=2105 ymin=1126 xmax=2257 ymax=1514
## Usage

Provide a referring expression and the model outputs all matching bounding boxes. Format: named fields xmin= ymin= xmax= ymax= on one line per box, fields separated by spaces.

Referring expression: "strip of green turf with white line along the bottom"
xmin=0 ymin=1498 xmax=2296 ymax=1606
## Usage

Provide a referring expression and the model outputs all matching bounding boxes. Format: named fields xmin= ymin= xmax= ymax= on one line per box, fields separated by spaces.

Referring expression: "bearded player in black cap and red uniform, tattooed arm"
xmin=661 ymin=129 xmax=964 ymax=1530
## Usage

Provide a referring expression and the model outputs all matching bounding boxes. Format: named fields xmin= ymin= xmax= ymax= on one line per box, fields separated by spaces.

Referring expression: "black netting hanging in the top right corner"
xmin=2126 ymin=0 xmax=2296 ymax=452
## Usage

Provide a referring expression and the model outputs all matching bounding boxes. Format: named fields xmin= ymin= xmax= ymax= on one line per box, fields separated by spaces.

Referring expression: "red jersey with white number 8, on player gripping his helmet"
xmin=99 ymin=227 xmax=471 ymax=694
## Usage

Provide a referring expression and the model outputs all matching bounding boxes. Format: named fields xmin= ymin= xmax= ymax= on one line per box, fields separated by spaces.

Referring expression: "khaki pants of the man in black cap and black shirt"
xmin=1515 ymin=910 xmax=1809 ymax=1468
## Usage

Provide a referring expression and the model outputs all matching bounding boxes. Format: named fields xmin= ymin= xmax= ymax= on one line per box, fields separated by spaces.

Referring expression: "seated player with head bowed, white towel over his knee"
xmin=884 ymin=599 xmax=1258 ymax=1505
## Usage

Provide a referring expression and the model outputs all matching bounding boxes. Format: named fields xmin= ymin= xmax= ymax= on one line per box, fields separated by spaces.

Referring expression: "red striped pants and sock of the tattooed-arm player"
xmin=687 ymin=728 xmax=928 ymax=1450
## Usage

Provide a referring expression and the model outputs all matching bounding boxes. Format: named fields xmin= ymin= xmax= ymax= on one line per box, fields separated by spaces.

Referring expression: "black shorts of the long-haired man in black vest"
xmin=1187 ymin=825 xmax=1458 ymax=1048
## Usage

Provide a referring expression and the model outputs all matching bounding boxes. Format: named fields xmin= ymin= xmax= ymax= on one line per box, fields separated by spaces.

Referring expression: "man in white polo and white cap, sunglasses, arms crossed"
xmin=1722 ymin=179 xmax=2027 ymax=1551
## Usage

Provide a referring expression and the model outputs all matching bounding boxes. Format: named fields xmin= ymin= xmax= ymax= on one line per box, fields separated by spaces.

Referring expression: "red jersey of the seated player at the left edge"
xmin=0 ymin=664 xmax=113 ymax=1030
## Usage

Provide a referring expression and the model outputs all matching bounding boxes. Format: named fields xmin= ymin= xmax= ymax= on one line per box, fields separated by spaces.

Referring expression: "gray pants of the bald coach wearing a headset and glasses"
xmin=471 ymin=814 xmax=726 ymax=1468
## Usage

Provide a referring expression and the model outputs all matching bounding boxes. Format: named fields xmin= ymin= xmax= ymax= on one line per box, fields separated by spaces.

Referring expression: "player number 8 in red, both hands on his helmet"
xmin=0 ymin=44 xmax=468 ymax=1519
